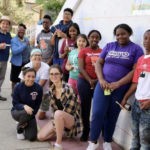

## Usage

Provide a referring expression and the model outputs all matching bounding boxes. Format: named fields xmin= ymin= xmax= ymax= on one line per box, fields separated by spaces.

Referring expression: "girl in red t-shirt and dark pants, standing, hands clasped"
xmin=77 ymin=30 xmax=102 ymax=141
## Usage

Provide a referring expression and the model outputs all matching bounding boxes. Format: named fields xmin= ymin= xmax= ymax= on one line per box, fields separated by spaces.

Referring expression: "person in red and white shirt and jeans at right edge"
xmin=121 ymin=30 xmax=150 ymax=150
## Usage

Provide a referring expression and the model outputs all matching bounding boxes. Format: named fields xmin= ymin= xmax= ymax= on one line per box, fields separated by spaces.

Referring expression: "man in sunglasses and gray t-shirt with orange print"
xmin=37 ymin=15 xmax=53 ymax=65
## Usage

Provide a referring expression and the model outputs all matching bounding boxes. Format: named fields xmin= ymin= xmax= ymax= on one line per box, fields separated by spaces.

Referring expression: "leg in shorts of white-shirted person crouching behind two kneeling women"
xmin=37 ymin=94 xmax=50 ymax=120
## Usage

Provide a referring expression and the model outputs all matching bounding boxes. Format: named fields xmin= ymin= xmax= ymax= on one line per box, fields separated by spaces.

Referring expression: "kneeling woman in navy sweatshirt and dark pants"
xmin=11 ymin=68 xmax=43 ymax=141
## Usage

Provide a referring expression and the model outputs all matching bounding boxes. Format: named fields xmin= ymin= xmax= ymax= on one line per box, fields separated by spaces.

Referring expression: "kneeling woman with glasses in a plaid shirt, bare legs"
xmin=38 ymin=65 xmax=82 ymax=150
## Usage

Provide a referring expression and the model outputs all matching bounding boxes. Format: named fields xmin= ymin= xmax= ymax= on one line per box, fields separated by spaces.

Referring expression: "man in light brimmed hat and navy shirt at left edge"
xmin=0 ymin=16 xmax=11 ymax=101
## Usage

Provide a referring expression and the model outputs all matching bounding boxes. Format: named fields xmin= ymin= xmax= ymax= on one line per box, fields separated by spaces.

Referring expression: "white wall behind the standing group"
xmin=55 ymin=0 xmax=150 ymax=149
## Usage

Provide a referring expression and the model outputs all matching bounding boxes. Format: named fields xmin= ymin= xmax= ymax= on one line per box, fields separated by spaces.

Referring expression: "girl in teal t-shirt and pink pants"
xmin=65 ymin=34 xmax=88 ymax=94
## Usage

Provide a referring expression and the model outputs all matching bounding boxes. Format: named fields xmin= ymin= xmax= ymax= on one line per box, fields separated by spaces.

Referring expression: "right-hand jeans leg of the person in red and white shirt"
xmin=139 ymin=105 xmax=150 ymax=150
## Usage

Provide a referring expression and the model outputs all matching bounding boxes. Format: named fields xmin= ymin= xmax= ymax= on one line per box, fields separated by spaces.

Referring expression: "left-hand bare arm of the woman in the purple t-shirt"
xmin=95 ymin=57 xmax=109 ymax=89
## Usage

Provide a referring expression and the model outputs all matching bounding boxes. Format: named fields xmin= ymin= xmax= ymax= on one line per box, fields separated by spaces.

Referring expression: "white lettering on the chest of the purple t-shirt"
xmin=107 ymin=50 xmax=129 ymax=59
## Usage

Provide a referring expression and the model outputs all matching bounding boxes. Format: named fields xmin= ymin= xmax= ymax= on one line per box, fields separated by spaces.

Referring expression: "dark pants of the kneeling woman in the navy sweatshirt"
xmin=11 ymin=110 xmax=37 ymax=141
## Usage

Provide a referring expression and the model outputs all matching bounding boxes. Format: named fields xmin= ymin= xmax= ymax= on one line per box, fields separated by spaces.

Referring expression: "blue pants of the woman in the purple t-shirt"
xmin=90 ymin=83 xmax=128 ymax=142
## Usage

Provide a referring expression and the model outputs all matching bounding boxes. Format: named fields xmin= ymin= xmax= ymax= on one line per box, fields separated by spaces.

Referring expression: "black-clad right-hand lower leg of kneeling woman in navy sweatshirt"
xmin=24 ymin=118 xmax=37 ymax=141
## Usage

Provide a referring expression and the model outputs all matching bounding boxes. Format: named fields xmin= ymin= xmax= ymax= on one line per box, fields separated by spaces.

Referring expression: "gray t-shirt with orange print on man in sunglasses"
xmin=37 ymin=30 xmax=53 ymax=62
